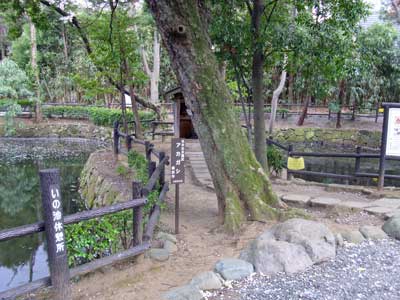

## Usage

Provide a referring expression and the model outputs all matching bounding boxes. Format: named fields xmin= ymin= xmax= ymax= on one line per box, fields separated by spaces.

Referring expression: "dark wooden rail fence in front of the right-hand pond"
xmin=267 ymin=137 xmax=400 ymax=185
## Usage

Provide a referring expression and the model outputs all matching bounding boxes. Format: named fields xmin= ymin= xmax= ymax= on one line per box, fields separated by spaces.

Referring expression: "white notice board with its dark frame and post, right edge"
xmin=378 ymin=103 xmax=400 ymax=190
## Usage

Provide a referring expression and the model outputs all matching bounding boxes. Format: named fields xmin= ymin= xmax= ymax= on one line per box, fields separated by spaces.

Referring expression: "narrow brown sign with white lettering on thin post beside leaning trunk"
xmin=171 ymin=138 xmax=185 ymax=234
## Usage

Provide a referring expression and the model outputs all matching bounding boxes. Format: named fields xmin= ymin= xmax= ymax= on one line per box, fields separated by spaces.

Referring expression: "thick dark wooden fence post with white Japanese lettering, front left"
xmin=39 ymin=169 xmax=72 ymax=300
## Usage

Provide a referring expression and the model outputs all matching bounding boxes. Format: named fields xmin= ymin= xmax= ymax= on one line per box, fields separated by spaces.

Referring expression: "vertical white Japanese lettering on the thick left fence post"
xmin=50 ymin=185 xmax=65 ymax=255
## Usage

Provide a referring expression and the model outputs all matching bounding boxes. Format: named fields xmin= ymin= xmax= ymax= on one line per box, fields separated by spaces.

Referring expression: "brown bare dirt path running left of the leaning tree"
xmin=69 ymin=172 xmax=272 ymax=300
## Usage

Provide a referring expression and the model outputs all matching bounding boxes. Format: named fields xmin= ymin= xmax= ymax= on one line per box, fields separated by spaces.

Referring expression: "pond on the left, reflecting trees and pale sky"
xmin=0 ymin=138 xmax=102 ymax=292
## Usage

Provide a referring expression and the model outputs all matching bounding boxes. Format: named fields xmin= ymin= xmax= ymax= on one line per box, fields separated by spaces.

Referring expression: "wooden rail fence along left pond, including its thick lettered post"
xmin=0 ymin=123 xmax=169 ymax=300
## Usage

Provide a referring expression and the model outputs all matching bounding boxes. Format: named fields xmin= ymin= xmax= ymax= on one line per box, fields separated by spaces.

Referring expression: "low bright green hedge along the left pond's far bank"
xmin=42 ymin=106 xmax=155 ymax=126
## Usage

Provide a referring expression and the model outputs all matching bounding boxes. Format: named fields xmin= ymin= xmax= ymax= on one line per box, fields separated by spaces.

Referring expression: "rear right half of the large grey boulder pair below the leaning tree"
xmin=263 ymin=219 xmax=336 ymax=263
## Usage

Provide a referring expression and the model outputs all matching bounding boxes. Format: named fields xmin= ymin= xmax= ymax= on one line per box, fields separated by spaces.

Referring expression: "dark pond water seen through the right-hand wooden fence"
xmin=288 ymin=143 xmax=400 ymax=187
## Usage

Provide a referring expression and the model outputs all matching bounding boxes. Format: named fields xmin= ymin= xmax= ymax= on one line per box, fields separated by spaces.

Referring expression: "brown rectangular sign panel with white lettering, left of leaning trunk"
xmin=171 ymin=138 xmax=185 ymax=184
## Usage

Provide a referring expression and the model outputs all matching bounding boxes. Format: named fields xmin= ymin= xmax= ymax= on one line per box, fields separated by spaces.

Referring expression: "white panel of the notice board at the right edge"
xmin=386 ymin=108 xmax=400 ymax=156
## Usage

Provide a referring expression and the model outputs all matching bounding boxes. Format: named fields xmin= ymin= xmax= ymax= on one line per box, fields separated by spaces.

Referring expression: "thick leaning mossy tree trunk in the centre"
xmin=147 ymin=0 xmax=280 ymax=231
